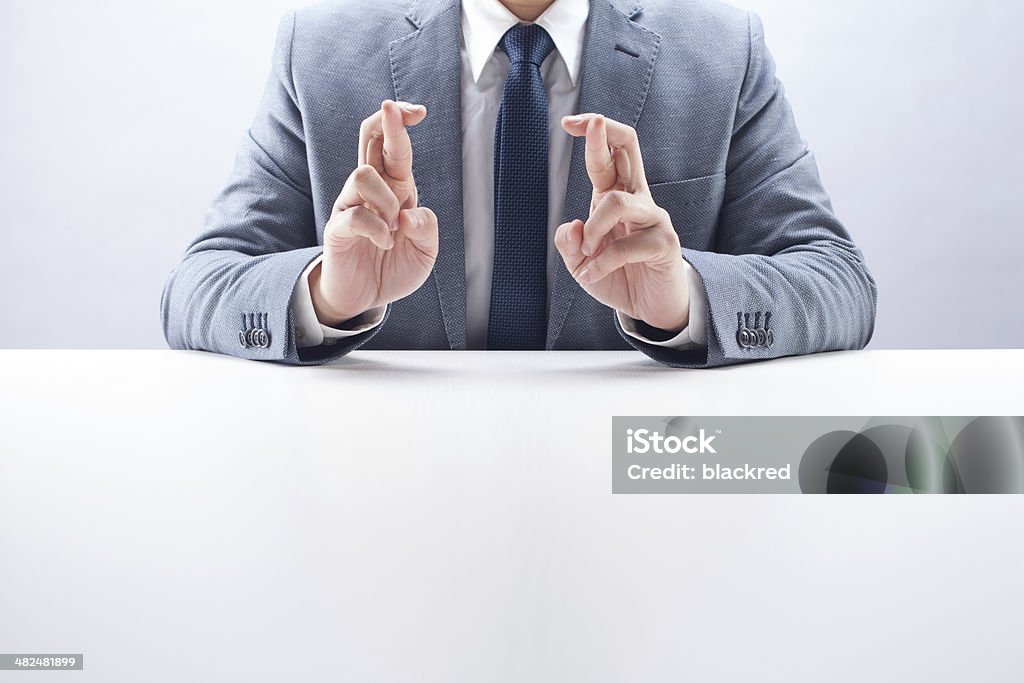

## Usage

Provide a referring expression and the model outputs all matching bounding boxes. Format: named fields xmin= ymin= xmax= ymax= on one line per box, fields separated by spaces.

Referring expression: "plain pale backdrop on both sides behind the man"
xmin=0 ymin=0 xmax=1024 ymax=348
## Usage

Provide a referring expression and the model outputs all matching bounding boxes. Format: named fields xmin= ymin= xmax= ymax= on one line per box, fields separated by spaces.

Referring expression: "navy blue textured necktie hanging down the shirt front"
xmin=487 ymin=24 xmax=555 ymax=350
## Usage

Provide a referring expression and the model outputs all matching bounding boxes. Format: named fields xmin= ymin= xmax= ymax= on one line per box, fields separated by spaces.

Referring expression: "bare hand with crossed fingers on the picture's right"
xmin=555 ymin=114 xmax=690 ymax=332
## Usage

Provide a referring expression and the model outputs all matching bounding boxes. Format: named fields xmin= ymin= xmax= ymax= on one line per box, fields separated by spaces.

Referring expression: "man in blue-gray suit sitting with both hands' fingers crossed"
xmin=161 ymin=0 xmax=877 ymax=368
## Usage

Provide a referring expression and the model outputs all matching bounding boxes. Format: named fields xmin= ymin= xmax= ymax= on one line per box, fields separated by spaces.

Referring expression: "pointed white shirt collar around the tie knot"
xmin=462 ymin=0 xmax=590 ymax=86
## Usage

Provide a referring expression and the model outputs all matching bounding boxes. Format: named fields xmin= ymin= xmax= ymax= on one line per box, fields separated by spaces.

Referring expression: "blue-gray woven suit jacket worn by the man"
xmin=161 ymin=0 xmax=876 ymax=368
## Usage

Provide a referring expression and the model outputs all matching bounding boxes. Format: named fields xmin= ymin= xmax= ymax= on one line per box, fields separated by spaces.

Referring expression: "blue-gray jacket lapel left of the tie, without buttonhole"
xmin=389 ymin=0 xmax=466 ymax=350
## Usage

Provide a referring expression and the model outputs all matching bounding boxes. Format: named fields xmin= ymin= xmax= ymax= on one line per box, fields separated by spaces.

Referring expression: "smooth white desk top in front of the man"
xmin=0 ymin=351 xmax=1024 ymax=683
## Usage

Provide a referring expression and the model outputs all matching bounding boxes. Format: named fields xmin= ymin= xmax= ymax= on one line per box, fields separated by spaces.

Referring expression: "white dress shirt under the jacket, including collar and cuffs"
xmin=291 ymin=0 xmax=708 ymax=349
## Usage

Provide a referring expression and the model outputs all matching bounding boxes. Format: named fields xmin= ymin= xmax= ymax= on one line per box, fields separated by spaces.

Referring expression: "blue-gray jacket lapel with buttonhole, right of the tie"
xmin=547 ymin=0 xmax=662 ymax=349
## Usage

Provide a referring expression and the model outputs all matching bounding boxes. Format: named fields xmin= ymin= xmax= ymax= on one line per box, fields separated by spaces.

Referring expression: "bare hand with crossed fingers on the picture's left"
xmin=309 ymin=100 xmax=437 ymax=327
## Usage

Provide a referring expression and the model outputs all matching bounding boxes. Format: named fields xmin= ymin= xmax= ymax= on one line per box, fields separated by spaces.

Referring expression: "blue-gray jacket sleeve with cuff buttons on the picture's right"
xmin=616 ymin=14 xmax=878 ymax=368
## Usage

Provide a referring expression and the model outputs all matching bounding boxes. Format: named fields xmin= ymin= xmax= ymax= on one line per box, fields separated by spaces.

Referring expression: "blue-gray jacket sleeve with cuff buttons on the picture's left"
xmin=161 ymin=13 xmax=386 ymax=365
